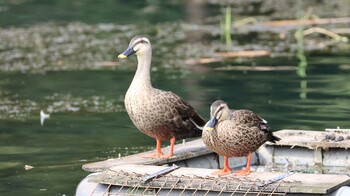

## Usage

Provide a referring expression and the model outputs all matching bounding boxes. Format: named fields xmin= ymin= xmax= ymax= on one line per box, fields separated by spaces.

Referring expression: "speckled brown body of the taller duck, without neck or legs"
xmin=125 ymin=88 xmax=205 ymax=140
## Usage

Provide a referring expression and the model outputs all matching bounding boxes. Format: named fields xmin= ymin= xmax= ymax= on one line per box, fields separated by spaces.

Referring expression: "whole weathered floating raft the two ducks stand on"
xmin=76 ymin=130 xmax=350 ymax=196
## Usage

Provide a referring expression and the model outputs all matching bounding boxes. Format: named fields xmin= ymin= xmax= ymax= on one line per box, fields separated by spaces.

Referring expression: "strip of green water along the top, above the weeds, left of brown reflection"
xmin=0 ymin=0 xmax=184 ymax=26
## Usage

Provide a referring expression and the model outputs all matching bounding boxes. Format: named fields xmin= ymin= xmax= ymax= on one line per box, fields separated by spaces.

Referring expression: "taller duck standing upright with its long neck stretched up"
xmin=118 ymin=35 xmax=205 ymax=159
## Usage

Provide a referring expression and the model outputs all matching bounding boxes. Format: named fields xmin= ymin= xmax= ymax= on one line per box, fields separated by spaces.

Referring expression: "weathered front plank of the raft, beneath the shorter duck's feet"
xmin=77 ymin=165 xmax=350 ymax=195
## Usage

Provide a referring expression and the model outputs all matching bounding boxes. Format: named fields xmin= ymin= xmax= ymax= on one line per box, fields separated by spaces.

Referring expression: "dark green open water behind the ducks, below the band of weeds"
xmin=0 ymin=59 xmax=350 ymax=195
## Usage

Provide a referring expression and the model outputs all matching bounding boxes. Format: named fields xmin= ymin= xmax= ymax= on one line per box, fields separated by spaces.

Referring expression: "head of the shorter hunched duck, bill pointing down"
xmin=204 ymin=100 xmax=230 ymax=131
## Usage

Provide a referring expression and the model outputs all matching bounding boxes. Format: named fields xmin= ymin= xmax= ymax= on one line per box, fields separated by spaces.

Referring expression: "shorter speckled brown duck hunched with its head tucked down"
xmin=202 ymin=100 xmax=280 ymax=176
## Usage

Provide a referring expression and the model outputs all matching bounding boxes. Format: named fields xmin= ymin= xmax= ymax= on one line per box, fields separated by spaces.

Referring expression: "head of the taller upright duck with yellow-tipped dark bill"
xmin=118 ymin=35 xmax=152 ymax=59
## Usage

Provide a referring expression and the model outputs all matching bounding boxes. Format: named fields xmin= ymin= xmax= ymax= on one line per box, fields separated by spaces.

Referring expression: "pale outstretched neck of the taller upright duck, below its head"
xmin=131 ymin=52 xmax=152 ymax=88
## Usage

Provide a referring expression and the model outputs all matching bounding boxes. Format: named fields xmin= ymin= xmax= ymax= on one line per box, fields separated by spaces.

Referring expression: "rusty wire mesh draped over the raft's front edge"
xmin=90 ymin=170 xmax=298 ymax=196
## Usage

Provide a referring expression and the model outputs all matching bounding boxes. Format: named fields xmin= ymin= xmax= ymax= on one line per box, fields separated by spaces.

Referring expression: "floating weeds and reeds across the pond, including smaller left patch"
xmin=0 ymin=1 xmax=350 ymax=119
